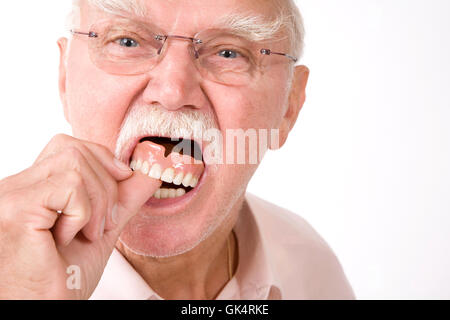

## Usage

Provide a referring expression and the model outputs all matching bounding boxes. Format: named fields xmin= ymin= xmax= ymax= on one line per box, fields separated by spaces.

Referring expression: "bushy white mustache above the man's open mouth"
xmin=115 ymin=105 xmax=218 ymax=159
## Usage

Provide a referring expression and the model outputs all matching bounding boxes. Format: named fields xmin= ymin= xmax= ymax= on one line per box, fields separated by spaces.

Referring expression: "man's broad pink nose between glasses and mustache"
xmin=143 ymin=39 xmax=208 ymax=111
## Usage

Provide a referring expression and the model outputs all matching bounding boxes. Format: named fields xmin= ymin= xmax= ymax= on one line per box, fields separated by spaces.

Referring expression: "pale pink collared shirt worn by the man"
xmin=91 ymin=193 xmax=355 ymax=300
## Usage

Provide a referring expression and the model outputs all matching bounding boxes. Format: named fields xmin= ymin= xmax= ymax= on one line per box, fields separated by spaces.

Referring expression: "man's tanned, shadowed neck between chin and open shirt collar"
xmin=117 ymin=197 xmax=244 ymax=300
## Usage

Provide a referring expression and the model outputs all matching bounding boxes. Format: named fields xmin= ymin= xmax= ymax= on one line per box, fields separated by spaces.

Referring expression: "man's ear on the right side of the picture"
xmin=279 ymin=66 xmax=309 ymax=148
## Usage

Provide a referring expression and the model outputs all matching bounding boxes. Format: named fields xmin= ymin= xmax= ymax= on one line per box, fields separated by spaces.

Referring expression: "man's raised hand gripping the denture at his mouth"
xmin=0 ymin=135 xmax=161 ymax=299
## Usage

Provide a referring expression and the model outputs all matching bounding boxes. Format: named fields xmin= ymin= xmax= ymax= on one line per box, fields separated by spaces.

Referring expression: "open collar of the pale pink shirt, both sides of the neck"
xmin=91 ymin=192 xmax=282 ymax=300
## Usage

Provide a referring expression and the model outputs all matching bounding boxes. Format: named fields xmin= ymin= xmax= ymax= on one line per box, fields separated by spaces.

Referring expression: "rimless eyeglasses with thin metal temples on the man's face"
xmin=71 ymin=18 xmax=297 ymax=85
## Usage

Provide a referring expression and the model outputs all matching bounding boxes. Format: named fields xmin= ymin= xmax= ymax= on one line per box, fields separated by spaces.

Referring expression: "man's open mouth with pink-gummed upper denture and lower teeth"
xmin=130 ymin=137 xmax=205 ymax=199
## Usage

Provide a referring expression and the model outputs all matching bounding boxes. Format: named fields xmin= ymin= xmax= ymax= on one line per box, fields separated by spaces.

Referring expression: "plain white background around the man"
xmin=0 ymin=0 xmax=450 ymax=299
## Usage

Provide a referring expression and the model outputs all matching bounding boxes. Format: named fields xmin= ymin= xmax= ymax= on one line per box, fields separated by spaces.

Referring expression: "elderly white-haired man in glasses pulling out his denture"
xmin=0 ymin=0 xmax=354 ymax=299
